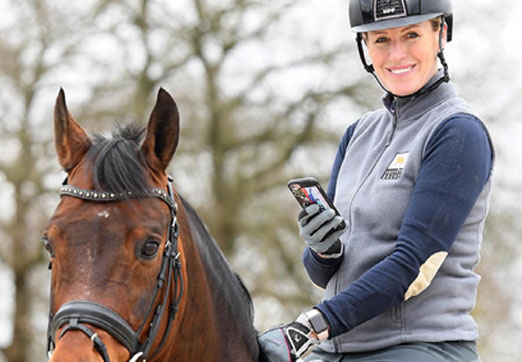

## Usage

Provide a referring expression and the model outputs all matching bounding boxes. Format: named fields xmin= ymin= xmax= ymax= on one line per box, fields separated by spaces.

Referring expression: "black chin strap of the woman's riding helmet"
xmin=355 ymin=16 xmax=450 ymax=98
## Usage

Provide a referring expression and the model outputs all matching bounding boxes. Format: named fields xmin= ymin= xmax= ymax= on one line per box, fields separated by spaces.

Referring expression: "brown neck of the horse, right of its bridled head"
xmin=157 ymin=202 xmax=257 ymax=362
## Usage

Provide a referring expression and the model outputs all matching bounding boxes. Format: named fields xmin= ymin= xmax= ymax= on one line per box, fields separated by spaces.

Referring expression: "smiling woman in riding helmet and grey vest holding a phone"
xmin=260 ymin=0 xmax=494 ymax=362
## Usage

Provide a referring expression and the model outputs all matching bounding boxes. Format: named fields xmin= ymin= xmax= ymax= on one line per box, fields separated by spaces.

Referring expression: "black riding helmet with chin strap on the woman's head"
xmin=349 ymin=0 xmax=453 ymax=97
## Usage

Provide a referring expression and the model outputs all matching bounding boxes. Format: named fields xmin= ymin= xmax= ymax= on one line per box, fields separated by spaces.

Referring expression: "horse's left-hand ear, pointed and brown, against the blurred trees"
xmin=54 ymin=88 xmax=92 ymax=172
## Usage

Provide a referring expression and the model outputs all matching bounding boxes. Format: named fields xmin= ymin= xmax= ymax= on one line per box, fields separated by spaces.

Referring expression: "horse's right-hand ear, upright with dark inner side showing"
xmin=141 ymin=88 xmax=179 ymax=172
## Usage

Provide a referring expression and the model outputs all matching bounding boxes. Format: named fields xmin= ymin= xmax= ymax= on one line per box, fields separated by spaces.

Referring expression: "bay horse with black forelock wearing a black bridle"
xmin=43 ymin=88 xmax=263 ymax=362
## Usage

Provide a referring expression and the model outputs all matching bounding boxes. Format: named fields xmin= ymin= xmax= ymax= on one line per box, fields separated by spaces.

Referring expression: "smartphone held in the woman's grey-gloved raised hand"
xmin=288 ymin=177 xmax=345 ymax=231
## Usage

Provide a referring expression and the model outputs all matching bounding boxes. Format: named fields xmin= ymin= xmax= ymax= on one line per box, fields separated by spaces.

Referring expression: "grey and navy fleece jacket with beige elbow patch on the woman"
xmin=303 ymin=73 xmax=494 ymax=352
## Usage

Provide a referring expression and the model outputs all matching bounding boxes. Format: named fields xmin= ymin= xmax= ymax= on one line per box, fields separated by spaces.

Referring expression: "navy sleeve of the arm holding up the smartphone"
xmin=303 ymin=122 xmax=357 ymax=288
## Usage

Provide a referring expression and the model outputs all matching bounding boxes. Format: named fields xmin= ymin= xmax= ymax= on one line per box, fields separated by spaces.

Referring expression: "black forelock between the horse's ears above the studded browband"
xmin=87 ymin=124 xmax=150 ymax=193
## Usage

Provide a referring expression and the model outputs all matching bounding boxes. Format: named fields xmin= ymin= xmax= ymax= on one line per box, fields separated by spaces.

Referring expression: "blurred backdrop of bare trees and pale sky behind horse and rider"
xmin=0 ymin=0 xmax=522 ymax=362
